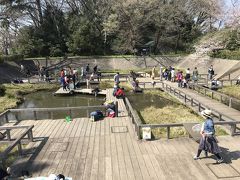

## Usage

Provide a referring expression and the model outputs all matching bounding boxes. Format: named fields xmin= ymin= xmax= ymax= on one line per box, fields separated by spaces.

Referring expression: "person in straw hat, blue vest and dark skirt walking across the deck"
xmin=194 ymin=109 xmax=223 ymax=163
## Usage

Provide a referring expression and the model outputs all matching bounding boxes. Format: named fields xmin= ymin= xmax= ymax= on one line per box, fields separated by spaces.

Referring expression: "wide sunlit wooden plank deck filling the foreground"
xmin=3 ymin=88 xmax=240 ymax=180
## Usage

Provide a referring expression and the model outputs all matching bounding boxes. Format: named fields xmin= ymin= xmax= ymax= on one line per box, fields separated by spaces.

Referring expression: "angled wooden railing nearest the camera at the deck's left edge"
xmin=0 ymin=125 xmax=34 ymax=165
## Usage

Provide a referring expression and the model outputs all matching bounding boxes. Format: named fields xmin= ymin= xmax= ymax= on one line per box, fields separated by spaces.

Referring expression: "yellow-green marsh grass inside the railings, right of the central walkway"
xmin=138 ymin=90 xmax=227 ymax=139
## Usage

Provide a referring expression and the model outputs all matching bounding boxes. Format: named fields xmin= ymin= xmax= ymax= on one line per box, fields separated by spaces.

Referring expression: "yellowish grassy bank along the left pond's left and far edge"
xmin=0 ymin=83 xmax=59 ymax=112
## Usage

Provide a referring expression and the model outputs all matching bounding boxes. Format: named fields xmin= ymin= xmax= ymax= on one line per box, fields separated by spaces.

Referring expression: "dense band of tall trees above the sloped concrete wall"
xmin=0 ymin=0 xmax=229 ymax=57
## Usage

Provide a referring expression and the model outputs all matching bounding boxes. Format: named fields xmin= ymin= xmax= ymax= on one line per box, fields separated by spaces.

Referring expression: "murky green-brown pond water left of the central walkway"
xmin=9 ymin=91 xmax=105 ymax=120
